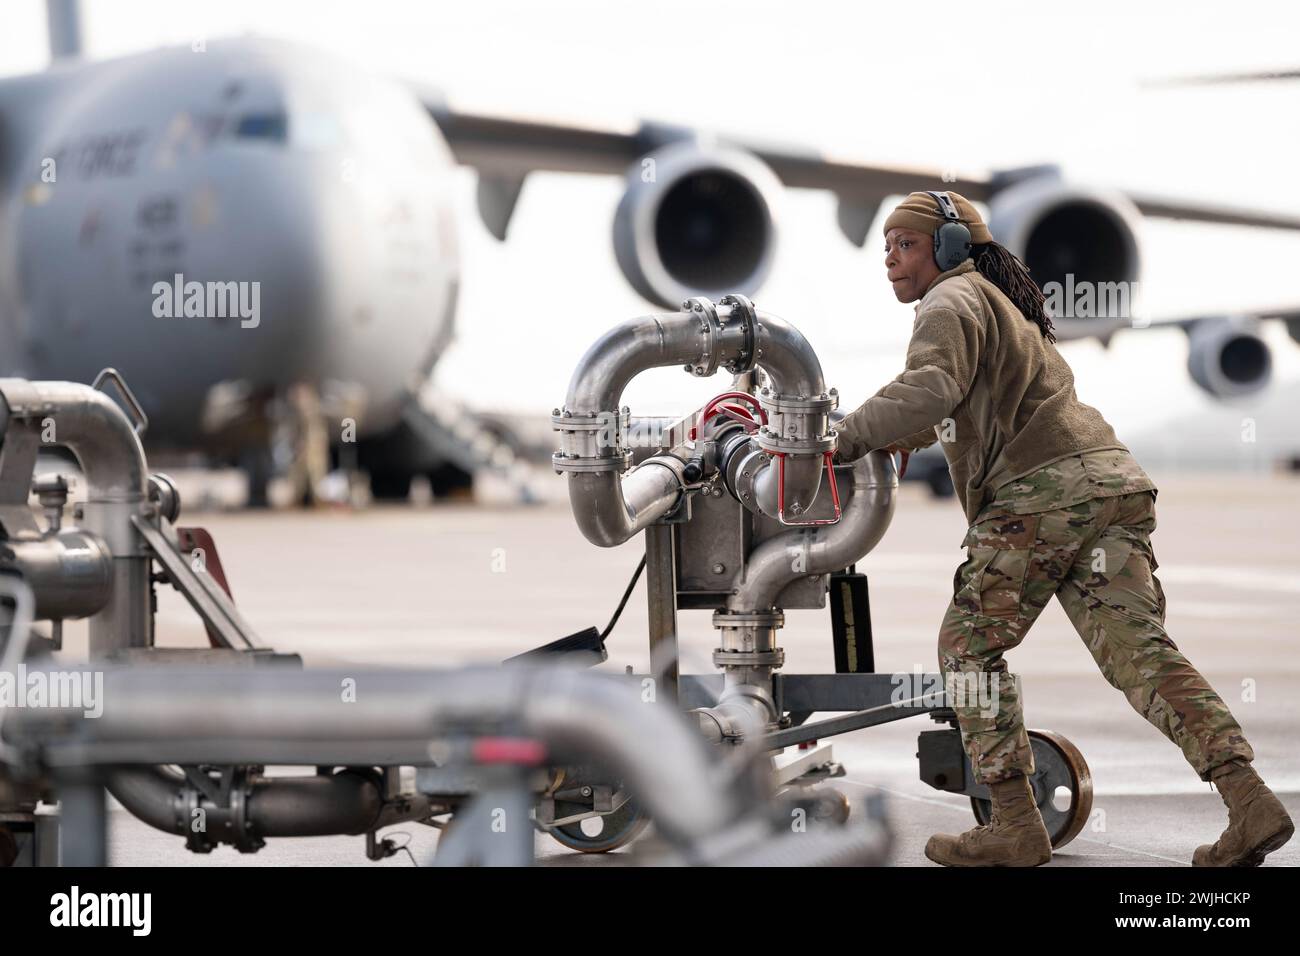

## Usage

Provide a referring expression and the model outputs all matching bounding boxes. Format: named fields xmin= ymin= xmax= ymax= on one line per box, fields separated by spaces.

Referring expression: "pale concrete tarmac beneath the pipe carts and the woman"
xmin=91 ymin=475 xmax=1300 ymax=866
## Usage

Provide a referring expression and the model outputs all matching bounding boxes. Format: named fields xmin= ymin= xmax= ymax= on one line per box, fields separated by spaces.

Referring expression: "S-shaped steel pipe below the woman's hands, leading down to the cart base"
xmin=727 ymin=451 xmax=898 ymax=611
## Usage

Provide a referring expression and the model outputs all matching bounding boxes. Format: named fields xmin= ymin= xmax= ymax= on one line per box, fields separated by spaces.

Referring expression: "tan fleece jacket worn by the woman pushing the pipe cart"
xmin=836 ymin=259 xmax=1127 ymax=523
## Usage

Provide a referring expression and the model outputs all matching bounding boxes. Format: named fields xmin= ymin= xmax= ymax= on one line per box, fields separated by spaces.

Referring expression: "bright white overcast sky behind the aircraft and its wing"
xmin=0 ymin=0 xmax=1300 ymax=460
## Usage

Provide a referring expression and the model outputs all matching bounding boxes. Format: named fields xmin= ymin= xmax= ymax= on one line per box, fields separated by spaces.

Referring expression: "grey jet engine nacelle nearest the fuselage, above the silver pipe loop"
xmin=614 ymin=142 xmax=781 ymax=308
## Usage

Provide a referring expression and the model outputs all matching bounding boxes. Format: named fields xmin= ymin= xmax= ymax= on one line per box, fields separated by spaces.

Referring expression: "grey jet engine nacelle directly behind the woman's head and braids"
xmin=988 ymin=176 xmax=1141 ymax=325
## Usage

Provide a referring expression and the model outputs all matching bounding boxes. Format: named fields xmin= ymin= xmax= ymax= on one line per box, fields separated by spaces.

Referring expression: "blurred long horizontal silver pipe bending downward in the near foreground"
xmin=12 ymin=666 xmax=757 ymax=843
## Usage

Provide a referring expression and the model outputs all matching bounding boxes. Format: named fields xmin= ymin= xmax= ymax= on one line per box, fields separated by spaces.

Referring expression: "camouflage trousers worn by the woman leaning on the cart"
xmin=939 ymin=492 xmax=1255 ymax=783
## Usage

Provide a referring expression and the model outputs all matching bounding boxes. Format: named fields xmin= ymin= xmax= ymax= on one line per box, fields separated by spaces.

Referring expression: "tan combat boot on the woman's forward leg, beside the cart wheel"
xmin=926 ymin=774 xmax=1052 ymax=866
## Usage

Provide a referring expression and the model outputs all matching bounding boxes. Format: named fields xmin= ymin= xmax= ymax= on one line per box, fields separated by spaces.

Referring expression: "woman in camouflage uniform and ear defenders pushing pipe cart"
xmin=837 ymin=193 xmax=1295 ymax=866
